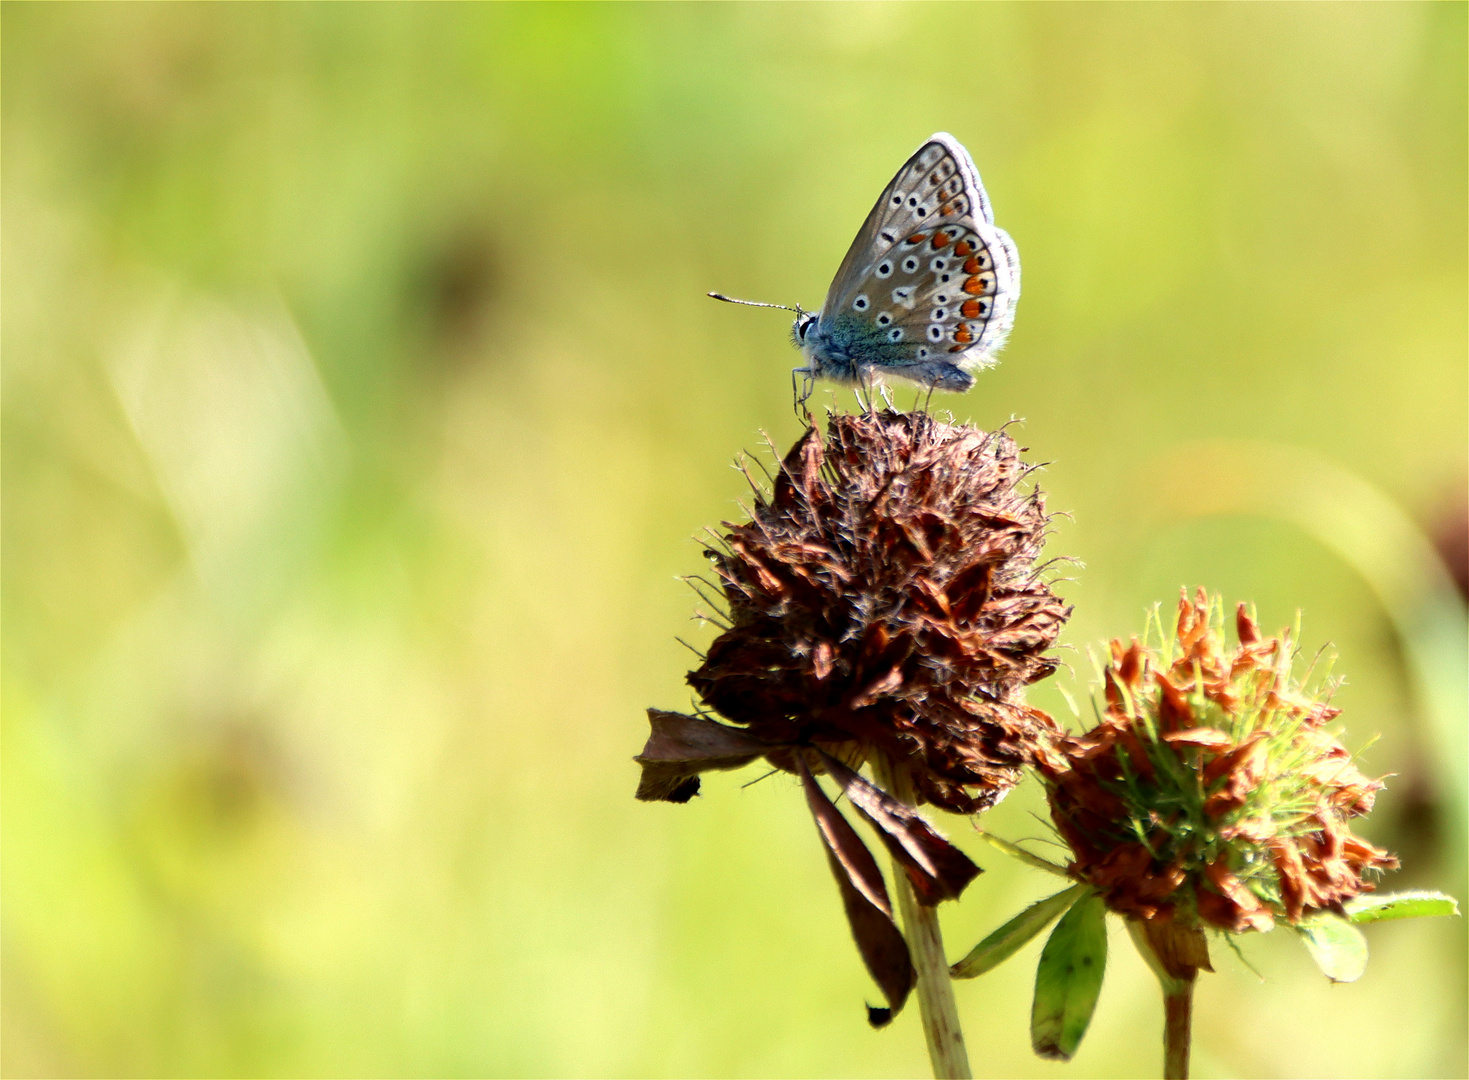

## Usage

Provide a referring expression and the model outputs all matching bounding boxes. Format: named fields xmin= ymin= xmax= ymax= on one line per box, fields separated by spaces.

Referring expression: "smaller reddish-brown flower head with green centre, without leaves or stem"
xmin=1039 ymin=589 xmax=1397 ymax=932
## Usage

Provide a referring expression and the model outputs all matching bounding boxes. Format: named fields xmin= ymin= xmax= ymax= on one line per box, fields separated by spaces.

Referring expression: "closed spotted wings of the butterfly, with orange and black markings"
xmin=821 ymin=134 xmax=1019 ymax=373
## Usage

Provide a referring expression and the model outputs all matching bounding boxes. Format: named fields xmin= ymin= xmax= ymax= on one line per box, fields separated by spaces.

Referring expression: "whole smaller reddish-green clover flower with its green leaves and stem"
xmin=950 ymin=589 xmax=1457 ymax=1080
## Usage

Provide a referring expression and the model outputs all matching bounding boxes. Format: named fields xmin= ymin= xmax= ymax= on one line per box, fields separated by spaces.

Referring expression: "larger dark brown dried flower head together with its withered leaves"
xmin=638 ymin=411 xmax=1069 ymax=1028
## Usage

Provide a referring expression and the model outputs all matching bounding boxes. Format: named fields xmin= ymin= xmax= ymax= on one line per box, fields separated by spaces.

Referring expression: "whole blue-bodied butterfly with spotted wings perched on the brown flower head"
xmin=710 ymin=131 xmax=1019 ymax=400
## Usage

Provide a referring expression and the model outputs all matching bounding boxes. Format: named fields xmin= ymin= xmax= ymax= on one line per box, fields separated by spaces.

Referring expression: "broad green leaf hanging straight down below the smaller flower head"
xmin=1030 ymin=893 xmax=1106 ymax=1061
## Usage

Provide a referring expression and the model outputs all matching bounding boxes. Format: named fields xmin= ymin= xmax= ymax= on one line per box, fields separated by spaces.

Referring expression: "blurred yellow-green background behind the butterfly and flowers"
xmin=3 ymin=3 xmax=1469 ymax=1077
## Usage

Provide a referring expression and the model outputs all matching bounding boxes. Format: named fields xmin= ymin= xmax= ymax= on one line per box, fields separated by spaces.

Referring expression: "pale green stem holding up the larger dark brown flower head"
xmin=873 ymin=754 xmax=972 ymax=1080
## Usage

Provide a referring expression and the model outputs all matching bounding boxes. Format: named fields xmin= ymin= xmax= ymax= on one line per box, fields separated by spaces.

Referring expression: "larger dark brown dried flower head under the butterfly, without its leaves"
xmin=675 ymin=411 xmax=1069 ymax=813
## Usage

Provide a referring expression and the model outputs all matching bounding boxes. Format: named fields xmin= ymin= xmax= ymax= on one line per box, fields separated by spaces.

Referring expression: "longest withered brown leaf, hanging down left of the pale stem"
xmin=796 ymin=755 xmax=917 ymax=1027
